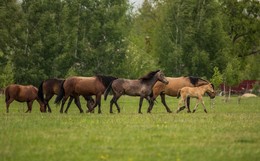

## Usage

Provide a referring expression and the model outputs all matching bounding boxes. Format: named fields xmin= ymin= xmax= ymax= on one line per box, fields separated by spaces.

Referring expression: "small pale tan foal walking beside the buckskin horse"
xmin=176 ymin=84 xmax=214 ymax=113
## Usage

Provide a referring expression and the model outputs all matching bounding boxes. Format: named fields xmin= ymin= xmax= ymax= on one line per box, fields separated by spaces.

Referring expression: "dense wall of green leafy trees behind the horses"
xmin=0 ymin=0 xmax=260 ymax=88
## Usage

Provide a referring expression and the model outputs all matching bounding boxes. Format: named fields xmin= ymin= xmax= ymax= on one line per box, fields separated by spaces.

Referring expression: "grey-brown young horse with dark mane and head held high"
xmin=104 ymin=70 xmax=168 ymax=113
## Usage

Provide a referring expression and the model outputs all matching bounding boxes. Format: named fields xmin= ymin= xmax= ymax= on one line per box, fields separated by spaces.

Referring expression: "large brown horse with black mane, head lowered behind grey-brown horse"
xmin=55 ymin=75 xmax=117 ymax=113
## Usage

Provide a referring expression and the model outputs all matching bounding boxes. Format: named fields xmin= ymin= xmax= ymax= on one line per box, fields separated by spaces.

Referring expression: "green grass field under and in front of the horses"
xmin=0 ymin=96 xmax=260 ymax=161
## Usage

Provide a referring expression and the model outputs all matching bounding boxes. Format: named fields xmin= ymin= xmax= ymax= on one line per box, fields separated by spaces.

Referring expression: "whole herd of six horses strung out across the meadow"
xmin=5 ymin=70 xmax=215 ymax=113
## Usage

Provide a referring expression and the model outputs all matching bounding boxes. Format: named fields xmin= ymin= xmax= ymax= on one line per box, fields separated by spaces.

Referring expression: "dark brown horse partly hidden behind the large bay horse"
xmin=38 ymin=78 xmax=94 ymax=112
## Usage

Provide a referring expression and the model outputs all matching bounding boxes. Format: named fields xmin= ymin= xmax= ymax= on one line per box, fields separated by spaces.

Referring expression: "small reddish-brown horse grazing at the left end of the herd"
xmin=5 ymin=84 xmax=44 ymax=113
